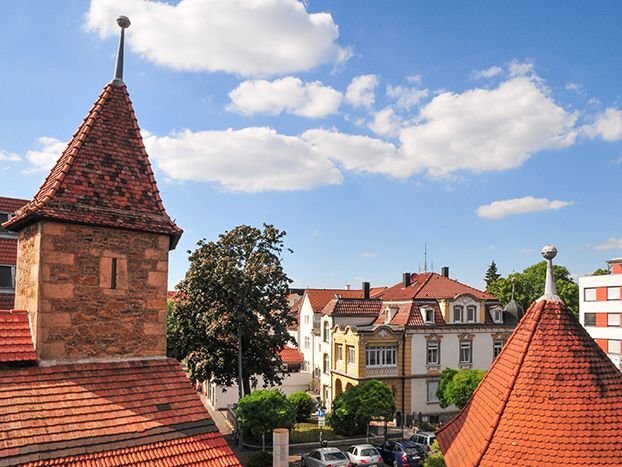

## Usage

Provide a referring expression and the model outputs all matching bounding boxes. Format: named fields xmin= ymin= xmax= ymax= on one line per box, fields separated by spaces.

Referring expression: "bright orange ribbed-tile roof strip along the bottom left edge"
xmin=23 ymin=433 xmax=242 ymax=467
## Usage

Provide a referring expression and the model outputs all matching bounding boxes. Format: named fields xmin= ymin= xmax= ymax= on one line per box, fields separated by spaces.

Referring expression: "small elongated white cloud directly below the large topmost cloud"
xmin=227 ymin=76 xmax=343 ymax=117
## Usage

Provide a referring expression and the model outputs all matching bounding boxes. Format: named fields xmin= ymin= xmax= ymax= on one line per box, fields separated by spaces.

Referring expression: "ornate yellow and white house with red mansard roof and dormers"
xmin=332 ymin=268 xmax=519 ymax=421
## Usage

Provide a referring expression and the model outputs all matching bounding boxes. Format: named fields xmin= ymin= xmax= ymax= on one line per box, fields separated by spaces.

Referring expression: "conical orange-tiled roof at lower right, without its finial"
xmin=437 ymin=300 xmax=622 ymax=467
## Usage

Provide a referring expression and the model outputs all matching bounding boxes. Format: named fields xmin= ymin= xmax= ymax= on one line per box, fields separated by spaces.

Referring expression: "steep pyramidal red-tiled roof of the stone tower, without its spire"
xmin=4 ymin=84 xmax=182 ymax=252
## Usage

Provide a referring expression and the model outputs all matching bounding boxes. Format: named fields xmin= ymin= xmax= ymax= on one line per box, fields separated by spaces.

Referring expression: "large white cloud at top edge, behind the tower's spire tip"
xmin=86 ymin=0 xmax=351 ymax=76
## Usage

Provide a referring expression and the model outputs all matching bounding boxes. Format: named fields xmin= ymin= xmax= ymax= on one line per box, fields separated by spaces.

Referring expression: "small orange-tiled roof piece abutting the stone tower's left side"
xmin=0 ymin=310 xmax=37 ymax=364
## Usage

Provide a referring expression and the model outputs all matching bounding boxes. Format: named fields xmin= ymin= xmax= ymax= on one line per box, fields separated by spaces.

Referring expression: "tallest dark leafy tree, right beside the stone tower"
xmin=170 ymin=225 xmax=293 ymax=395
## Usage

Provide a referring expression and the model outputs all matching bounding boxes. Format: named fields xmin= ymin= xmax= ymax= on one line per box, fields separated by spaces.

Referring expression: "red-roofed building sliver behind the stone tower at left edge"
xmin=0 ymin=196 xmax=28 ymax=310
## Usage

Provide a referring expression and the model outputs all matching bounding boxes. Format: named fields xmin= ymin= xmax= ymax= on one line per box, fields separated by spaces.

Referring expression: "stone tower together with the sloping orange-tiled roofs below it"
xmin=0 ymin=17 xmax=241 ymax=466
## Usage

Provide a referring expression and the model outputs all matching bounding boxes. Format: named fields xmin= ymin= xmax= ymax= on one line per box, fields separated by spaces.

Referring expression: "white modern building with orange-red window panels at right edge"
xmin=579 ymin=258 xmax=622 ymax=371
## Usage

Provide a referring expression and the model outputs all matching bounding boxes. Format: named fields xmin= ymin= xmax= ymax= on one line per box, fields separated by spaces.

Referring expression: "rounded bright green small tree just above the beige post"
xmin=236 ymin=389 xmax=296 ymax=448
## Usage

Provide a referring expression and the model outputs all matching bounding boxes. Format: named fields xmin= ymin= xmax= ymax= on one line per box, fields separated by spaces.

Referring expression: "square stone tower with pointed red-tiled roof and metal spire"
xmin=4 ymin=21 xmax=182 ymax=361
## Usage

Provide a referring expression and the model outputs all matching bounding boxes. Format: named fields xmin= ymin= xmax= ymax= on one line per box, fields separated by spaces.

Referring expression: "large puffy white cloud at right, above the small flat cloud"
xmin=400 ymin=76 xmax=578 ymax=177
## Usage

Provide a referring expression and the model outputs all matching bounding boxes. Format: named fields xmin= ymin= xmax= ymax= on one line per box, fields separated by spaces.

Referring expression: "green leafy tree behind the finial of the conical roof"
xmin=487 ymin=261 xmax=579 ymax=316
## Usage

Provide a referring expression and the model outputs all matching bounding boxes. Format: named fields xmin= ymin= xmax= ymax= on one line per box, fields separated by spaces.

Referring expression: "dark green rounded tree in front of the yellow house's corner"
xmin=328 ymin=380 xmax=395 ymax=436
